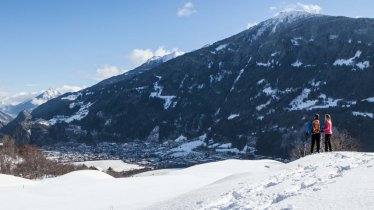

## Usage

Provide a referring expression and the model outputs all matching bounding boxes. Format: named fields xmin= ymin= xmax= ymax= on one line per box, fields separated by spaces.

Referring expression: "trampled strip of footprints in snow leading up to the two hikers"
xmin=200 ymin=153 xmax=374 ymax=210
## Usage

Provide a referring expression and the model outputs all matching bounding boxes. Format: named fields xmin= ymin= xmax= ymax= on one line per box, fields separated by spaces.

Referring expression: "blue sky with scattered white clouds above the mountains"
xmin=0 ymin=0 xmax=374 ymax=103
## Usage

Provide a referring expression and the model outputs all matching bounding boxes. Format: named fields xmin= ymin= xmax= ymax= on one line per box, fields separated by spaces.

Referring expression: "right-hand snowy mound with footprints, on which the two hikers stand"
xmin=147 ymin=152 xmax=374 ymax=210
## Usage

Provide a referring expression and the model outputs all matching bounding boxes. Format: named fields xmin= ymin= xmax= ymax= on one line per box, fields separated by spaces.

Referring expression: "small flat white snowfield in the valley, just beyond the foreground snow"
xmin=73 ymin=160 xmax=144 ymax=172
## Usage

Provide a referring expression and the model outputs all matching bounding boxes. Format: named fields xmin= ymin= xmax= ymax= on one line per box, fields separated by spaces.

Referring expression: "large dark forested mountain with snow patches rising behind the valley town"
xmin=3 ymin=12 xmax=374 ymax=160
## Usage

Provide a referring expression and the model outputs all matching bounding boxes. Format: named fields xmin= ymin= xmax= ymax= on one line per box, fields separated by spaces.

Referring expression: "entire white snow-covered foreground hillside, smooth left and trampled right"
xmin=0 ymin=152 xmax=374 ymax=210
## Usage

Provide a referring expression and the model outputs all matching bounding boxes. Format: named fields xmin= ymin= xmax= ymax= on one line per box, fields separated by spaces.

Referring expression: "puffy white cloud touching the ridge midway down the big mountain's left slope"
xmin=128 ymin=46 xmax=183 ymax=67
